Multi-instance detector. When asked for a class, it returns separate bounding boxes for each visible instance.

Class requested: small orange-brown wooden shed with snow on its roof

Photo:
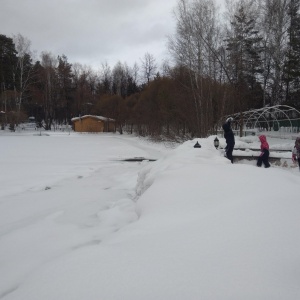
[71,115,115,132]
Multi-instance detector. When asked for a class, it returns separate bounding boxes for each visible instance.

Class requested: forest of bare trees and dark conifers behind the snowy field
[0,0,300,139]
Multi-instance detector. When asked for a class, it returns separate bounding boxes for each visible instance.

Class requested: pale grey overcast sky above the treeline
[0,0,223,69]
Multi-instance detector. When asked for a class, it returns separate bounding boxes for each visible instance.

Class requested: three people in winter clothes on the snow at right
[222,117,300,169]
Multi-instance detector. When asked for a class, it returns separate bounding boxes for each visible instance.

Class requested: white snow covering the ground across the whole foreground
[0,131,300,300]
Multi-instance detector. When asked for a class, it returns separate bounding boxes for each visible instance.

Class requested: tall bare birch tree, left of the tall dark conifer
[169,0,222,136]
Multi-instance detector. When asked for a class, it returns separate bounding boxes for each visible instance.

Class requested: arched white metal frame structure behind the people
[222,105,300,132]
